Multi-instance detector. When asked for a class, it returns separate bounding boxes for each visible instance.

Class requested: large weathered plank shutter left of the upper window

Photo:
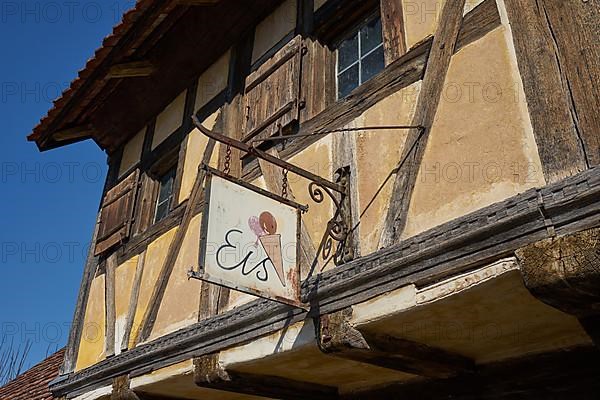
[242,36,302,141]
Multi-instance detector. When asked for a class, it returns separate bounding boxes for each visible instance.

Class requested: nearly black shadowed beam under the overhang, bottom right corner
[342,346,600,400]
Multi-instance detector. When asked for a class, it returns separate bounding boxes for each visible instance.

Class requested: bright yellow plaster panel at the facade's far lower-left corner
[75,275,106,371]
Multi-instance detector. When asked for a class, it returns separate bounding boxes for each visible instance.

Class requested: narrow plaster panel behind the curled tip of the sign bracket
[179,110,221,203]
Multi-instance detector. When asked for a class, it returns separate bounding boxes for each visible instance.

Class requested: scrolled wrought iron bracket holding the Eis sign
[192,115,353,273]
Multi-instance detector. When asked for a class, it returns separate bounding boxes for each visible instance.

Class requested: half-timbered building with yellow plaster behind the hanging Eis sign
[29,0,600,400]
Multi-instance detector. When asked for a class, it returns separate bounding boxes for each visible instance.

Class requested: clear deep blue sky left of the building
[0,0,133,366]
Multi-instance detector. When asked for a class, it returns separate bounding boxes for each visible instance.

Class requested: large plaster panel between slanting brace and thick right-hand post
[404,28,545,237]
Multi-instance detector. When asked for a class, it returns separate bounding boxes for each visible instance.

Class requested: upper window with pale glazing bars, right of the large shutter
[336,16,385,99]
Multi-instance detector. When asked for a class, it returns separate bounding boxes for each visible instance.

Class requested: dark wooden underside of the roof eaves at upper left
[28,0,282,153]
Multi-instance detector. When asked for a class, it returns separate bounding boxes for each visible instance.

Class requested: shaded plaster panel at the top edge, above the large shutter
[252,0,297,62]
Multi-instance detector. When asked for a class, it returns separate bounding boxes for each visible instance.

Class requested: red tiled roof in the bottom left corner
[0,349,65,400]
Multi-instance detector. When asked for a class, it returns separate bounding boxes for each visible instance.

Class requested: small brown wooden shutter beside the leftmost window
[94,170,139,255]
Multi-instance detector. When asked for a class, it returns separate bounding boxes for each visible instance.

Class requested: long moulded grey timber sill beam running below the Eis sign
[51,167,600,395]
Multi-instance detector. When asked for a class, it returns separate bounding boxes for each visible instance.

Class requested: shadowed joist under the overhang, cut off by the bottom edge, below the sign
[194,353,338,400]
